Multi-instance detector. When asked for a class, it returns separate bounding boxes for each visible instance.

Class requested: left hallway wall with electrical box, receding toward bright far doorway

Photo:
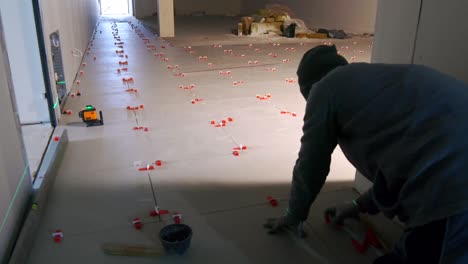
[40,0,99,116]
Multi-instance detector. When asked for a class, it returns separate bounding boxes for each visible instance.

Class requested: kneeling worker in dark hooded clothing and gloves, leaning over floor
[265,46,468,264]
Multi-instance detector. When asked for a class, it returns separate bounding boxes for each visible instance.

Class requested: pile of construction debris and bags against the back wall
[238,4,349,39]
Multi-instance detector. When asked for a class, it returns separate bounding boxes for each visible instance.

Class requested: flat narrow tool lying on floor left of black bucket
[101,243,166,257]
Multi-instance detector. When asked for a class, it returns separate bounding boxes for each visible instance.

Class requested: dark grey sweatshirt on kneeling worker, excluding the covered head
[289,63,468,227]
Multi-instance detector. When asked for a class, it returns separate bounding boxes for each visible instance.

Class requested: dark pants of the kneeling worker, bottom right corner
[374,211,468,264]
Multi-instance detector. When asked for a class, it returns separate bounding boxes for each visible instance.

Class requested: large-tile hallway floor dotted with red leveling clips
[29,19,398,264]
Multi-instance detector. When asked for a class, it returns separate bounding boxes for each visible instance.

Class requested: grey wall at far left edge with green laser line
[0,14,31,263]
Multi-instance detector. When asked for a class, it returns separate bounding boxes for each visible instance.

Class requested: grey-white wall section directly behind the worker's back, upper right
[372,0,468,82]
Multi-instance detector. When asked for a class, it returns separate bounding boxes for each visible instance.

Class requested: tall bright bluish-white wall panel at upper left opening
[0,0,50,123]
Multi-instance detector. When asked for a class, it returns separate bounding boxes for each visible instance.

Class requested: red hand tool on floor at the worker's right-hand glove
[325,211,385,256]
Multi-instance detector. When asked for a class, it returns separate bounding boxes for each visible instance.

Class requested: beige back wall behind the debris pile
[242,0,377,33]
